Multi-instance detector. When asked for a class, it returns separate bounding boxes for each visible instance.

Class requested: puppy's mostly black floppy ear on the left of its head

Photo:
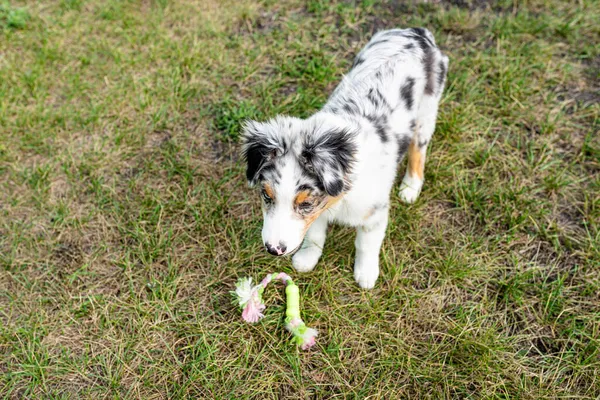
[242,121,283,186]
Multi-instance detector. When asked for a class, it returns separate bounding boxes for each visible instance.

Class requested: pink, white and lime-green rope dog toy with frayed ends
[231,272,318,350]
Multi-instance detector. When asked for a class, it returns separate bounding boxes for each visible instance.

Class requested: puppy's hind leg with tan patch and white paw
[399,56,448,203]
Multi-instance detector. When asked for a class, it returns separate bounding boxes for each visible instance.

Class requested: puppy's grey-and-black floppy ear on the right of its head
[302,129,356,196]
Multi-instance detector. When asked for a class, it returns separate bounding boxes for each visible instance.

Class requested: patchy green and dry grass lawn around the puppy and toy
[0,0,600,399]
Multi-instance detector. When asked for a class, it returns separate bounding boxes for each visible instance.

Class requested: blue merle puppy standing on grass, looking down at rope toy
[243,28,448,288]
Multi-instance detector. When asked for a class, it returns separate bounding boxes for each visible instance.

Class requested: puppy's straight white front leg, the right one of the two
[354,205,388,289]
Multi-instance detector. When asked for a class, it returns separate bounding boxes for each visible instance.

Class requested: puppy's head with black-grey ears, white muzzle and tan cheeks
[243,117,356,255]
